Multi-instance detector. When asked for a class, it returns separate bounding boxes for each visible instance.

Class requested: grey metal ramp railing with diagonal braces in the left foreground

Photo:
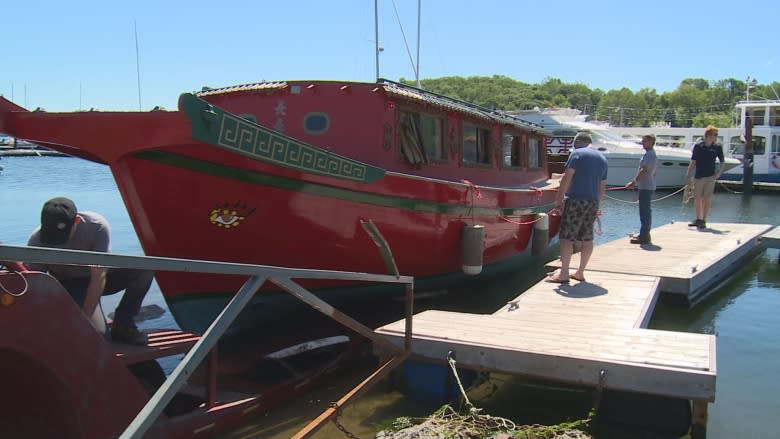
[0,242,414,439]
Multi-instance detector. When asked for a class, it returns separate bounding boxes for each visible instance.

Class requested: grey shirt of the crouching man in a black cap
[27,212,111,279]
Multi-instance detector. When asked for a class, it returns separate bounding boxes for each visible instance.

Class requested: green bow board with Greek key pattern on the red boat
[179,93,385,183]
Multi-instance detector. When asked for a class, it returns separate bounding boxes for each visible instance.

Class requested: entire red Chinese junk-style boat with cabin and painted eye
[0,80,558,332]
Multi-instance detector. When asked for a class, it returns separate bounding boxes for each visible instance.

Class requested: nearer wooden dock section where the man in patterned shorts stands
[376,272,716,401]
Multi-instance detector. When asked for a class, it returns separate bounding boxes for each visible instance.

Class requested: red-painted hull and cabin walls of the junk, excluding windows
[0,83,558,332]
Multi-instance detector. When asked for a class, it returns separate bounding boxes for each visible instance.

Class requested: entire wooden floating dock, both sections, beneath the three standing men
[376,224,772,438]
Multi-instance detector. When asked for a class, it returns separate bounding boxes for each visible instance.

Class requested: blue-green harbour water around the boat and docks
[0,157,780,438]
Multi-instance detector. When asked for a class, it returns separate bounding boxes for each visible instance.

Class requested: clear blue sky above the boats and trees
[0,0,780,111]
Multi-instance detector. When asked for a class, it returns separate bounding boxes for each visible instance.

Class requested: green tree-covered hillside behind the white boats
[399,75,780,127]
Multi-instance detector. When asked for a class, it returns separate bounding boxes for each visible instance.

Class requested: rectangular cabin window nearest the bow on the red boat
[398,111,447,166]
